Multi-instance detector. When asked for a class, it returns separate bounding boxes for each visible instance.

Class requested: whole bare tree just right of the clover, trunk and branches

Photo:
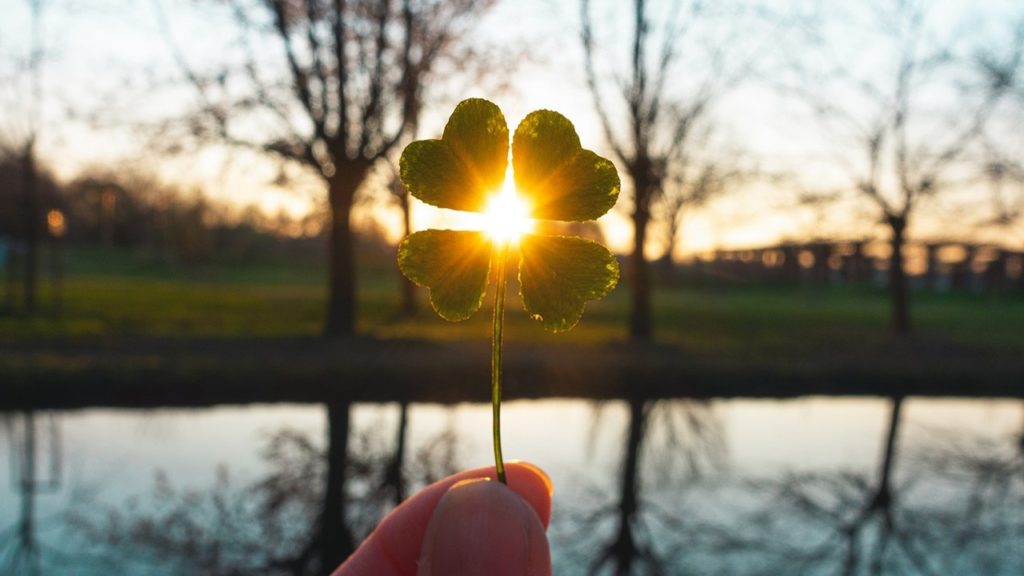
[580,0,750,341]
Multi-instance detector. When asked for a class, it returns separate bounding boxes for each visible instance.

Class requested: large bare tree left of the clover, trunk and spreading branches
[157,0,494,336]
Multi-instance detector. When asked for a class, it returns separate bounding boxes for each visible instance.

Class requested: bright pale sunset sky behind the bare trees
[0,0,1024,256]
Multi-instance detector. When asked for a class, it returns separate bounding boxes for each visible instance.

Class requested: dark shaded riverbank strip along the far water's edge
[0,332,1024,410]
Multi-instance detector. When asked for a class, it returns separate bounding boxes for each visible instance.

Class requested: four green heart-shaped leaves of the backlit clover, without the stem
[398,98,620,331]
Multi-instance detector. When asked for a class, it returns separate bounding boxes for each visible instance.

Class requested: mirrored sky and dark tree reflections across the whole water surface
[0,398,1024,576]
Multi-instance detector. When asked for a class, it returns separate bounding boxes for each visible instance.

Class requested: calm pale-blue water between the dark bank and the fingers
[0,398,1024,575]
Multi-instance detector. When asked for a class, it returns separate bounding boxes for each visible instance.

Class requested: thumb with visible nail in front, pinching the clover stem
[418,479,551,576]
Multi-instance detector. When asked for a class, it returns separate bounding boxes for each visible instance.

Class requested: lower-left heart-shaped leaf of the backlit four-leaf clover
[398,230,492,322]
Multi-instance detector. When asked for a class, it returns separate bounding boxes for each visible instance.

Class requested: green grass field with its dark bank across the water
[0,247,1024,409]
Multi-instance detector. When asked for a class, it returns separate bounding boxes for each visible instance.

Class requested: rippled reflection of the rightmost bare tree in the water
[704,399,1024,575]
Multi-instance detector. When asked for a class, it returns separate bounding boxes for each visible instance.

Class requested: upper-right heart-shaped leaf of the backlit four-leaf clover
[512,110,620,221]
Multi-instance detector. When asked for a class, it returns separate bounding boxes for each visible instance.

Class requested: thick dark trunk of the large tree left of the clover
[324,167,366,337]
